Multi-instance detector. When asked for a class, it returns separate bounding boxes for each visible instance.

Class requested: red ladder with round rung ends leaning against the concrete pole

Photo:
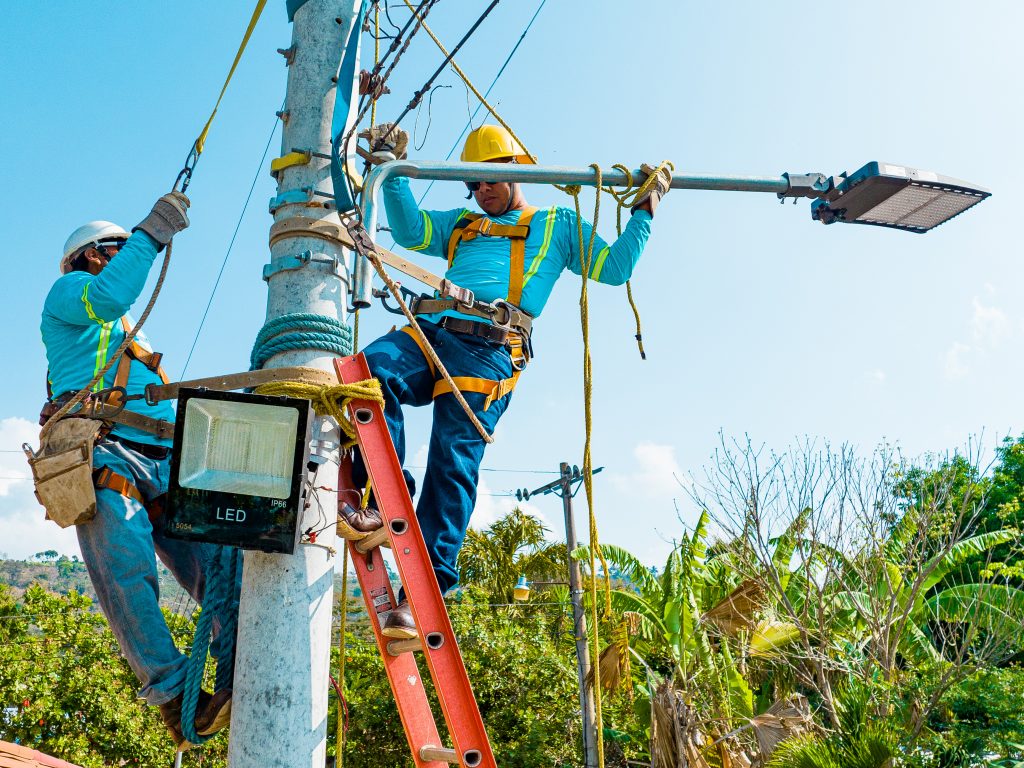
[335,354,496,768]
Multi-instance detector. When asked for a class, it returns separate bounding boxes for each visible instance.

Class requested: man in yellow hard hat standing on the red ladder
[338,123,672,638]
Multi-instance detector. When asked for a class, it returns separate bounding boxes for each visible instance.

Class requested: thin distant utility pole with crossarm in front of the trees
[516,462,604,768]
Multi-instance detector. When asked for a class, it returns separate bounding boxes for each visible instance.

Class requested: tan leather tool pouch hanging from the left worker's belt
[29,418,103,528]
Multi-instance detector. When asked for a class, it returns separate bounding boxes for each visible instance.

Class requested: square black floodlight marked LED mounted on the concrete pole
[165,389,312,553]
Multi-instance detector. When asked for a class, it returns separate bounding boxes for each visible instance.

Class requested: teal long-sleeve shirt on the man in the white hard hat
[40,230,174,445]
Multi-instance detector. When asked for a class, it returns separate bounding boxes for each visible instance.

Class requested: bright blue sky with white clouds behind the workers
[0,0,1024,563]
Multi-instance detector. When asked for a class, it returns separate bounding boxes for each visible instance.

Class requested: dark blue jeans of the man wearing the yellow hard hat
[352,321,513,594]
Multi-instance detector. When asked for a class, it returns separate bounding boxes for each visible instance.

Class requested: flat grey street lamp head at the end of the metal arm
[811,163,991,233]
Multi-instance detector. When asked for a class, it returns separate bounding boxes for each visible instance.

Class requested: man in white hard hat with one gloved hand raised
[40,191,237,749]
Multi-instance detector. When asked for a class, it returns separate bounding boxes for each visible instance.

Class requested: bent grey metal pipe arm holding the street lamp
[352,160,830,307]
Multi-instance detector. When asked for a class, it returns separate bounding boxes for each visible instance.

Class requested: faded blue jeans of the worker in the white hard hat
[77,440,241,705]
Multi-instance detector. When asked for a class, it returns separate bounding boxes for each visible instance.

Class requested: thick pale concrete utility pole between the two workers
[228,0,358,768]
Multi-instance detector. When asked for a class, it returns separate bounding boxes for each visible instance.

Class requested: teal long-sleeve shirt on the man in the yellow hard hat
[384,177,651,323]
